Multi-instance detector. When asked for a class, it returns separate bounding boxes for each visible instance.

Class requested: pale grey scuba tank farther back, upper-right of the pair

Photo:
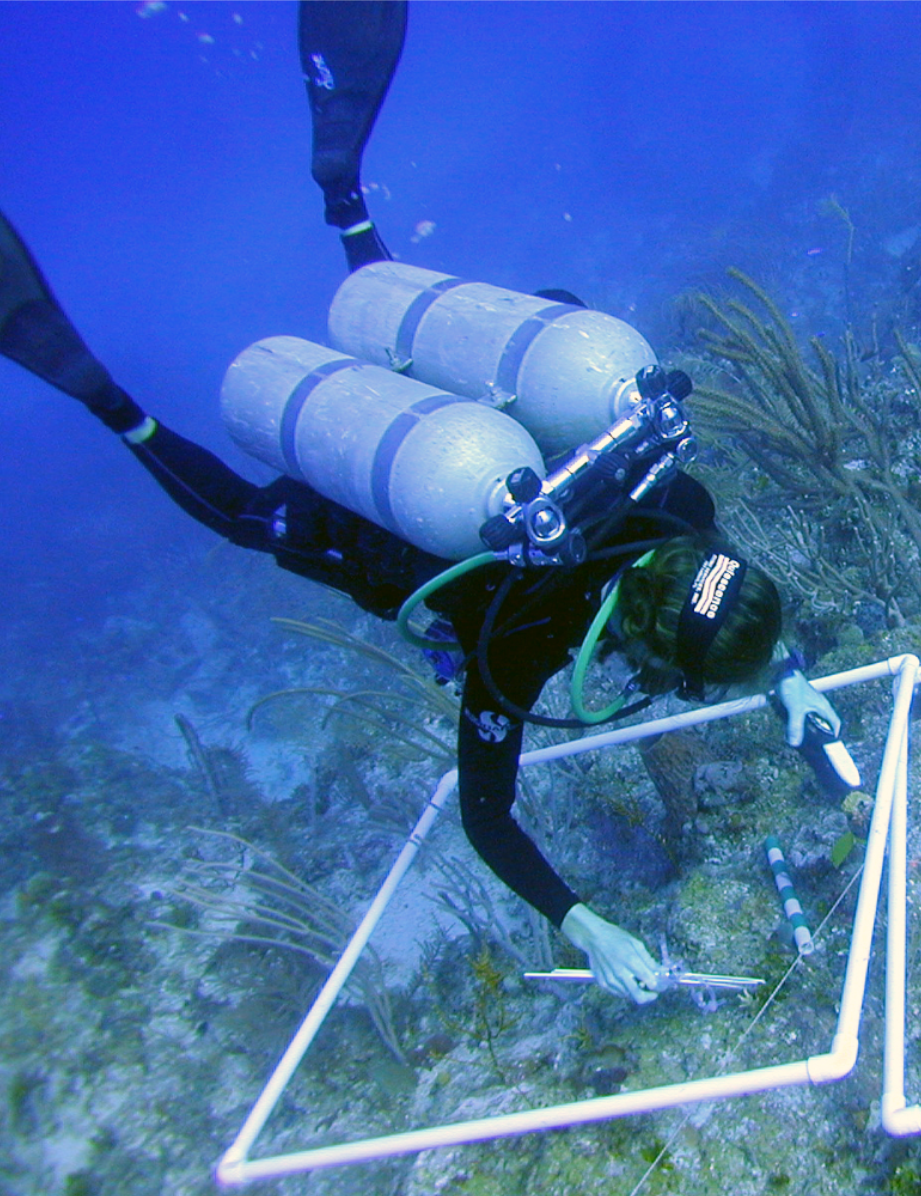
[329,262,655,458]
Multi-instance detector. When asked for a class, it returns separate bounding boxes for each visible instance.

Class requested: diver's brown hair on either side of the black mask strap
[617,536,782,685]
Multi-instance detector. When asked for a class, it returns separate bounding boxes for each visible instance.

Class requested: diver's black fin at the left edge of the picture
[0,212,144,432]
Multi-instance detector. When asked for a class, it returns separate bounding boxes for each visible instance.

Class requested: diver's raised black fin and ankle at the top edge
[299,0,407,270]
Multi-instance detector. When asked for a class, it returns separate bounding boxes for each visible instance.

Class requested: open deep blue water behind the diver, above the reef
[0,0,921,645]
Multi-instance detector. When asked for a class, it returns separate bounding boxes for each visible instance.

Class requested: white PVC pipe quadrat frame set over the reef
[216,654,921,1186]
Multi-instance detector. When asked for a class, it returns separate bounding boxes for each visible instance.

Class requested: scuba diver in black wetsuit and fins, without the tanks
[0,0,840,1003]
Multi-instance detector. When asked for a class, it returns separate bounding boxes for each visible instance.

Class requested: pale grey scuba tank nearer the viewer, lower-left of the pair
[221,336,545,560]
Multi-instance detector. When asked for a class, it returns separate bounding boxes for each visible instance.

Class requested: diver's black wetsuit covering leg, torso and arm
[123,427,714,926]
